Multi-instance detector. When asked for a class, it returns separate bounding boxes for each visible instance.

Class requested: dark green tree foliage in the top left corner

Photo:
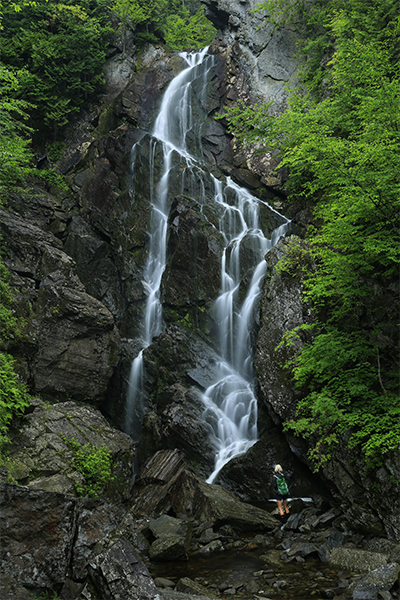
[0,0,108,134]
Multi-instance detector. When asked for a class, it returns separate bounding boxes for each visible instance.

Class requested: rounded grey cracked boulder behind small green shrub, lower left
[5,399,135,500]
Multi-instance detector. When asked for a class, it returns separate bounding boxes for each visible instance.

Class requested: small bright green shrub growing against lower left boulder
[63,438,115,496]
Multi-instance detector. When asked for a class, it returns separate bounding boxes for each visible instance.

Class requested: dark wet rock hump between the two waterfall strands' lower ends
[134,325,218,477]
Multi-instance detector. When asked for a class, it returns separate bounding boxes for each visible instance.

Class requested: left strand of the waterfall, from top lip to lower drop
[124,48,212,441]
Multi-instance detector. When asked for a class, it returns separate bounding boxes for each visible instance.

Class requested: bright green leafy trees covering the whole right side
[227,0,400,468]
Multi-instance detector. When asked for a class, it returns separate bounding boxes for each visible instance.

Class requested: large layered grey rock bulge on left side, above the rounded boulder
[0,211,120,403]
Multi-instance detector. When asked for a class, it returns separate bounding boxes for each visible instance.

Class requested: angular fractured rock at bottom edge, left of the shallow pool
[88,538,159,600]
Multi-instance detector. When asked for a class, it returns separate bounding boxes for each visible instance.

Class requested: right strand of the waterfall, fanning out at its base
[203,178,289,483]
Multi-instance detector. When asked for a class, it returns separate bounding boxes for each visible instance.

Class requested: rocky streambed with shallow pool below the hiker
[145,500,400,600]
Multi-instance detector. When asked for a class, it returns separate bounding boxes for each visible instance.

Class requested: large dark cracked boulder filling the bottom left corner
[0,483,126,589]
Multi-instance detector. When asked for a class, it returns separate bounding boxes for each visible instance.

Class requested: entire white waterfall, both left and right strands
[125,49,289,483]
